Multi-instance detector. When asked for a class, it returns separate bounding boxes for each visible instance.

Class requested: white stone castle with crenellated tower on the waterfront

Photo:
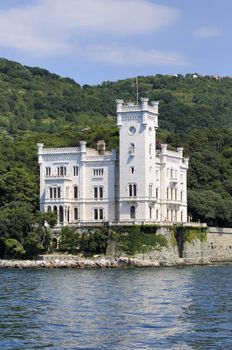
[38,98,188,227]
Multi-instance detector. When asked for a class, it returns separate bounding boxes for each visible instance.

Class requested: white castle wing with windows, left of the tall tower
[38,142,116,224]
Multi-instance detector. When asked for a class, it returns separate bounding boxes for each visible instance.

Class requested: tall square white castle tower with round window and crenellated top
[116,98,159,222]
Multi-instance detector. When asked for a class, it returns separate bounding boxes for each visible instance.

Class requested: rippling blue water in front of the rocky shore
[0,266,232,350]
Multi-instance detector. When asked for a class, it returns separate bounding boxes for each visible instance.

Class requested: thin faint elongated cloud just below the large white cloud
[84,44,188,66]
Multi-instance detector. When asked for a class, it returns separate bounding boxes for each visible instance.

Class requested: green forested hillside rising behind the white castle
[0,59,232,253]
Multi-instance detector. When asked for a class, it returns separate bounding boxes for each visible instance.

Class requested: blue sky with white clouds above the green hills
[0,0,232,85]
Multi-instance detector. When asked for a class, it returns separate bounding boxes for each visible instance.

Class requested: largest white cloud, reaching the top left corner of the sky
[0,0,180,56]
